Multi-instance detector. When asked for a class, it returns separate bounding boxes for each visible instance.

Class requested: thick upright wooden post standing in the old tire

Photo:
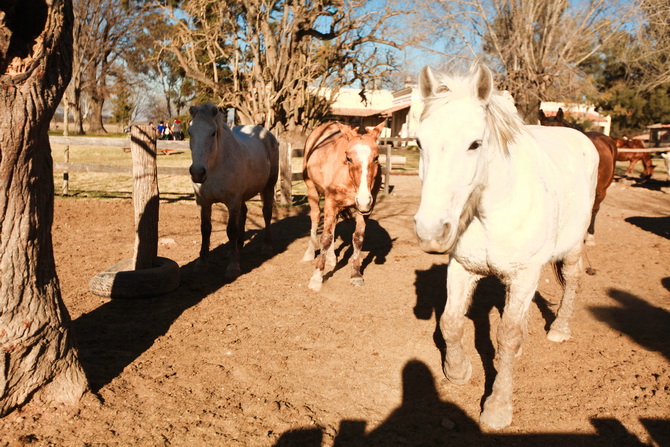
[130,126,159,270]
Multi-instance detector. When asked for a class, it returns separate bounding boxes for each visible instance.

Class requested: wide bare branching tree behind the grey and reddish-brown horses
[163,0,403,131]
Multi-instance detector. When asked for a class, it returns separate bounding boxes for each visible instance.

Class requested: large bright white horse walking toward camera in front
[414,64,598,429]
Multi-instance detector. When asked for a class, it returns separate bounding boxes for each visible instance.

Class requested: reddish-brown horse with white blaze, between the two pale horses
[302,122,385,291]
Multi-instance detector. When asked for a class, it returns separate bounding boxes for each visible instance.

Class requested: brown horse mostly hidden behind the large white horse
[538,109,618,245]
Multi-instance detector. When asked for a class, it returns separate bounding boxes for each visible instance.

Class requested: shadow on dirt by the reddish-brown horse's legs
[323,219,395,281]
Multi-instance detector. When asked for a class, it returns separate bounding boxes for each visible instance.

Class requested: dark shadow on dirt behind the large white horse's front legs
[413,264,505,405]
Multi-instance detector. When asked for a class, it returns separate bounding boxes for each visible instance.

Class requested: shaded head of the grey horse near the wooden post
[188,103,220,183]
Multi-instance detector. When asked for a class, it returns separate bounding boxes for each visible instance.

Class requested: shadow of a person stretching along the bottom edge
[274,360,670,447]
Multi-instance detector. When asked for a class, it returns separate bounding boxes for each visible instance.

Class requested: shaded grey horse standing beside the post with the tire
[188,104,279,278]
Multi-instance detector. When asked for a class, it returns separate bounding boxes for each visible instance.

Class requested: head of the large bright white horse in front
[414,64,510,253]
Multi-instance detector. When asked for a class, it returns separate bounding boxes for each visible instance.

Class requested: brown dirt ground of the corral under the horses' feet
[0,176,670,447]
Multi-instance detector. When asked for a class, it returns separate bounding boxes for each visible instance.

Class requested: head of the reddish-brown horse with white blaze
[338,122,385,214]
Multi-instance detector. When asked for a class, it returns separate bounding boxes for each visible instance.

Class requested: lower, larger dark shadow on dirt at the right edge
[589,288,670,360]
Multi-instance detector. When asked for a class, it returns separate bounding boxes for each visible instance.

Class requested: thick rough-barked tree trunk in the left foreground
[0,0,87,417]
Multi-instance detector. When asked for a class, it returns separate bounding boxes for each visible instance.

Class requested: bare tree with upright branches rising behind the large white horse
[412,0,635,122]
